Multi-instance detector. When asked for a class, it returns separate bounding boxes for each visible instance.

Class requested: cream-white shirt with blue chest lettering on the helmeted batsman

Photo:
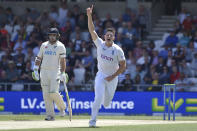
[38,41,66,70]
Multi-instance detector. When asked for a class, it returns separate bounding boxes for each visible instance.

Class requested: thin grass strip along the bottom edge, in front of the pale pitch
[1,124,197,131]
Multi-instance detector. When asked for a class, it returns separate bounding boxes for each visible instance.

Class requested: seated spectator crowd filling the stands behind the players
[0,3,197,91]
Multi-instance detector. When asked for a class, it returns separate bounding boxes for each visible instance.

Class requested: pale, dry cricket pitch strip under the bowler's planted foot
[0,119,197,130]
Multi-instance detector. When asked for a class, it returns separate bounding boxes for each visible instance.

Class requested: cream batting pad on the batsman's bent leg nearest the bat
[50,93,66,110]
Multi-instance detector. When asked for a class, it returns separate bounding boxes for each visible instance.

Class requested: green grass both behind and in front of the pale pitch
[0,115,197,131]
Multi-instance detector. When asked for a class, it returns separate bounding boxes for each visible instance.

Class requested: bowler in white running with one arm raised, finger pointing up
[87,5,126,127]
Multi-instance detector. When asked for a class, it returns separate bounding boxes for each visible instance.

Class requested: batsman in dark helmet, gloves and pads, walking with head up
[32,28,68,121]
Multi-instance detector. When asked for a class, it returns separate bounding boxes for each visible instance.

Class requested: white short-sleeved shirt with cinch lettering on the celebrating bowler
[94,37,125,75]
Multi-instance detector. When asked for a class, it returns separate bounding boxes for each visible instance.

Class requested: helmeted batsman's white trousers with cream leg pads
[40,69,66,117]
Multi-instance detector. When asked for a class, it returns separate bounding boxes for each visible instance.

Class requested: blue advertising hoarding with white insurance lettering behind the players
[0,92,197,115]
